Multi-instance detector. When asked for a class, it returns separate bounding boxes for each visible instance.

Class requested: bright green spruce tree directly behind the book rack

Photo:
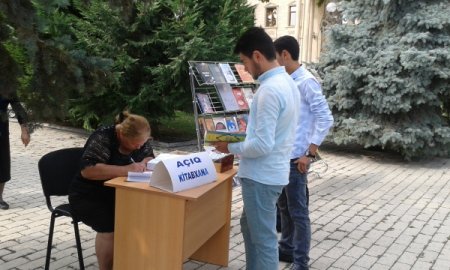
[71,0,253,130]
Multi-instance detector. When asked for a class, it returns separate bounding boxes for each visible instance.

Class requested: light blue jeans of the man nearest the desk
[240,178,283,270]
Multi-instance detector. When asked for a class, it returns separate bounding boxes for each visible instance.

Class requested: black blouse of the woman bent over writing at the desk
[70,126,154,195]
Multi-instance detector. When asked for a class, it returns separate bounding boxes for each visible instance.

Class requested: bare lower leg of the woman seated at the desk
[95,232,114,270]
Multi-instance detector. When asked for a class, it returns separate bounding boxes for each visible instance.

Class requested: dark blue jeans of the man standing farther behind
[278,160,311,270]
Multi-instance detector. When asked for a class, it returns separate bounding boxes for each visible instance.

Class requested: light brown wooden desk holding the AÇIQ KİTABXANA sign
[105,168,236,270]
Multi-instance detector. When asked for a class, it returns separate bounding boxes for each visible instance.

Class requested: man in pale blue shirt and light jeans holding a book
[215,27,300,270]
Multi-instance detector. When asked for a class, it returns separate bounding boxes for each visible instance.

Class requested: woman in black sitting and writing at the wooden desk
[69,111,154,270]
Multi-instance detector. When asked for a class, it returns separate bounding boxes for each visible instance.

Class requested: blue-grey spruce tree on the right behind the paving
[320,0,450,159]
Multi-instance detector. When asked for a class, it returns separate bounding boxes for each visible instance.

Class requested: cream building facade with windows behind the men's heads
[248,0,325,63]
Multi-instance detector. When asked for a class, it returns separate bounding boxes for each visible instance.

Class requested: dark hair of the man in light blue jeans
[234,27,276,61]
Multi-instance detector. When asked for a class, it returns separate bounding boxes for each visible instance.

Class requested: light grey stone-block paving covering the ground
[0,122,450,270]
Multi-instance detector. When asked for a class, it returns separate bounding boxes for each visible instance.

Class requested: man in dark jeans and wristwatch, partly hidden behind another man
[274,36,333,270]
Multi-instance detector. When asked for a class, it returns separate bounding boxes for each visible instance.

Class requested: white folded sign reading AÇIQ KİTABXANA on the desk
[150,152,217,192]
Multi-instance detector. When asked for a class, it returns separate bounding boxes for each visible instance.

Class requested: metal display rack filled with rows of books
[188,61,258,151]
